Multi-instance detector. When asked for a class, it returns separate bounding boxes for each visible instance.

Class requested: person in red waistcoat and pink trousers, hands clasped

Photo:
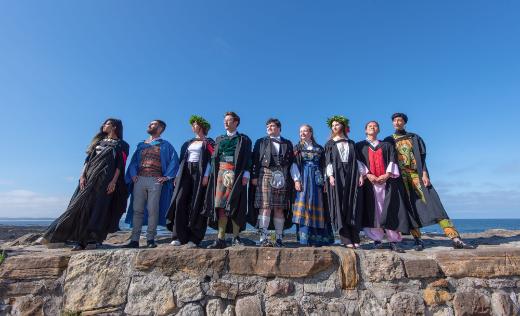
[356,121,410,252]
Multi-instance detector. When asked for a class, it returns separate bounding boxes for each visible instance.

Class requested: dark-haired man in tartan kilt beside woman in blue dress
[249,118,294,247]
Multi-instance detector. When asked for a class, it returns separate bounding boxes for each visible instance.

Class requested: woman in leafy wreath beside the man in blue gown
[166,115,215,247]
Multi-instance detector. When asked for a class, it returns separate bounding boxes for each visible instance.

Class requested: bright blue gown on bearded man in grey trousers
[125,139,179,226]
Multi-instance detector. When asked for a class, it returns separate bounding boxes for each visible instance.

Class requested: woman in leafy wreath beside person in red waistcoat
[325,115,363,248]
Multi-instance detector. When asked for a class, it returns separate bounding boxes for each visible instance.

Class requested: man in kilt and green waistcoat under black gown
[204,112,251,249]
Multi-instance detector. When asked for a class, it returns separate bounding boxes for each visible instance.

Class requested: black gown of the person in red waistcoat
[356,140,410,234]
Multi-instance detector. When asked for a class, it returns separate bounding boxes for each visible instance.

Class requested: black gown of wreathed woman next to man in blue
[166,138,215,244]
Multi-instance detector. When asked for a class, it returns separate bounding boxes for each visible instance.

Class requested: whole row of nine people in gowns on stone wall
[43,112,474,252]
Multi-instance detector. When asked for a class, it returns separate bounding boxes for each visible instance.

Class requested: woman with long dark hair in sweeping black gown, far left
[43,118,129,250]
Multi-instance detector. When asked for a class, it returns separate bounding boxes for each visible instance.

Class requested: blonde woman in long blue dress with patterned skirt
[291,124,334,246]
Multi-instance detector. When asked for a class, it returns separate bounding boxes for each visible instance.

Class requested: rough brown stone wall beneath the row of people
[0,246,520,315]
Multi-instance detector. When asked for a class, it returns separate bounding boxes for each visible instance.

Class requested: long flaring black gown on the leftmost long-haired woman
[43,141,129,245]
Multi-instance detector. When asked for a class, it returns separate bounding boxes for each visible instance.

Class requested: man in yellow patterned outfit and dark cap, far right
[385,113,475,251]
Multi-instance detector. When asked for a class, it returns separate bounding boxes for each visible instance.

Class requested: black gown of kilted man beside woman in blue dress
[247,136,294,230]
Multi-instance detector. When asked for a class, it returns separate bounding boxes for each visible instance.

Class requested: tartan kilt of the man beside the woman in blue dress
[255,168,289,209]
